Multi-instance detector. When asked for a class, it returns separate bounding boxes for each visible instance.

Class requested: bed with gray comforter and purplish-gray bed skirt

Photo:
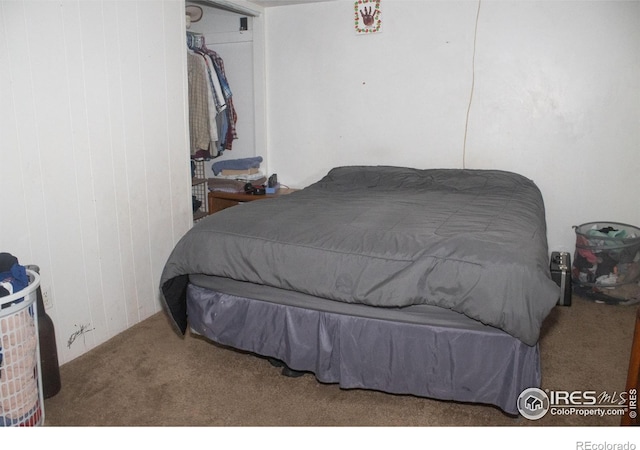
[160,166,560,415]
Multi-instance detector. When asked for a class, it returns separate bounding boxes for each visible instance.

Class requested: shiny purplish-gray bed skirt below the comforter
[187,284,540,415]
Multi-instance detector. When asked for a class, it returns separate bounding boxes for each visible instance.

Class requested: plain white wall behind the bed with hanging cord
[265,0,640,252]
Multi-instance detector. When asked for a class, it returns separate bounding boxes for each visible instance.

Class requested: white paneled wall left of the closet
[0,0,192,363]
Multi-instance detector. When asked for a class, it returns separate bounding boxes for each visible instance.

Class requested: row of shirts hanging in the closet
[187,33,238,159]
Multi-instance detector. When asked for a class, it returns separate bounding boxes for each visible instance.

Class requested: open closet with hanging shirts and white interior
[185,0,268,222]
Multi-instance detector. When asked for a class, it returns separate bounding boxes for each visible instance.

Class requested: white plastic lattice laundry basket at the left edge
[0,269,44,427]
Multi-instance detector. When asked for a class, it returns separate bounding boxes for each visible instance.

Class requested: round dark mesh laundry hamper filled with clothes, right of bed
[571,222,640,304]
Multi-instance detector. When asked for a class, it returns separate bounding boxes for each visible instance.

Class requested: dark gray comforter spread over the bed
[160,166,559,345]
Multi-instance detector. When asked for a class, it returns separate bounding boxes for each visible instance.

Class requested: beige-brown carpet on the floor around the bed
[45,297,637,427]
